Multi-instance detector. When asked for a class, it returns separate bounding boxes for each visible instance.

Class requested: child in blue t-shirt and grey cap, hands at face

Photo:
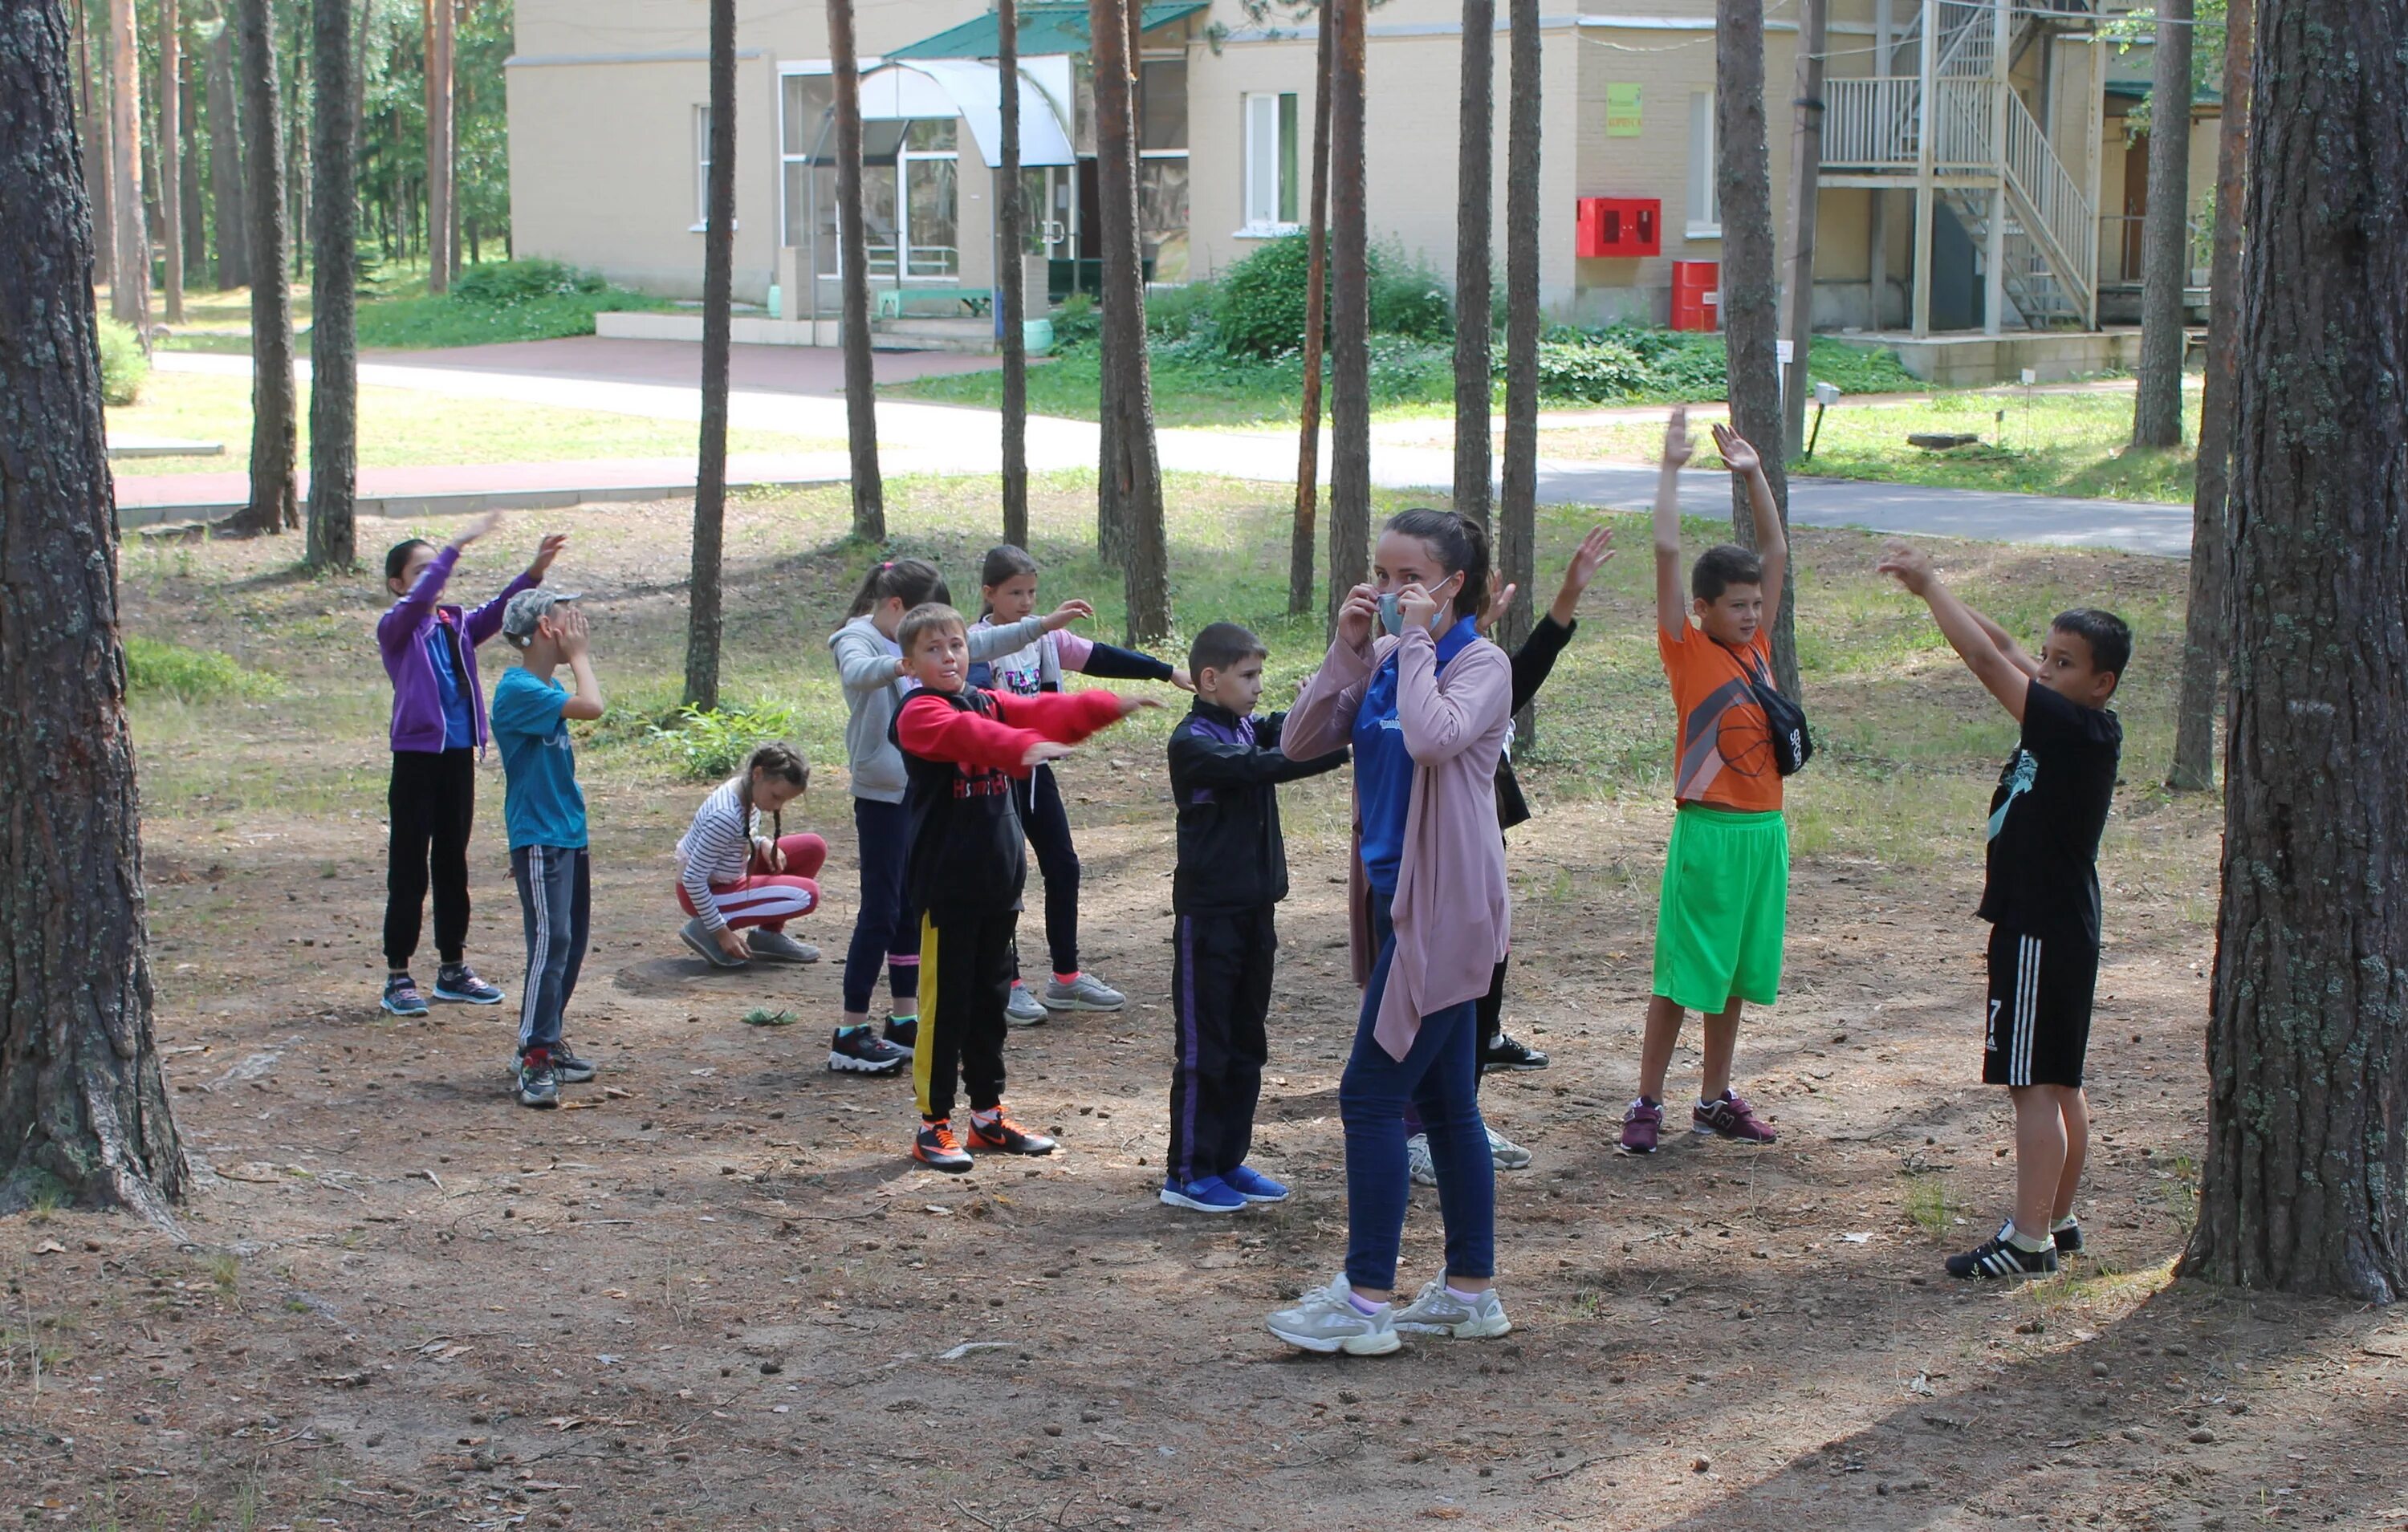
[494,590,602,1106]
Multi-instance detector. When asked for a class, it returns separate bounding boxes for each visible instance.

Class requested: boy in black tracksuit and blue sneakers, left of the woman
[1163,621,1346,1212]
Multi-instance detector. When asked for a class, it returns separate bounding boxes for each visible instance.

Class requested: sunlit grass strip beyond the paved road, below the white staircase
[1539,380,2199,503]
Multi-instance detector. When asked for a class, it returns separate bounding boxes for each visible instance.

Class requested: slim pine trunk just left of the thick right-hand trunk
[2165,0,2256,793]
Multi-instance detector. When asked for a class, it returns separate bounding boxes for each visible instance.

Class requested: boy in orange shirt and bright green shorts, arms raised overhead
[1621,409,1789,1154]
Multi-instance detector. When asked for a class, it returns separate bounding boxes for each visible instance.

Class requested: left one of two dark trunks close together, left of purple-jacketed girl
[224,0,301,534]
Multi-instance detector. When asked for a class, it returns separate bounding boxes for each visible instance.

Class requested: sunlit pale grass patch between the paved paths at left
[108,371,845,477]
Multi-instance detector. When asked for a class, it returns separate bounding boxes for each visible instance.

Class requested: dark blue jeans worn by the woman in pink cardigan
[1339,892,1495,1289]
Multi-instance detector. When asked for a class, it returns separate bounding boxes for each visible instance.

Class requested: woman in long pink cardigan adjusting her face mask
[1271,510,1512,1356]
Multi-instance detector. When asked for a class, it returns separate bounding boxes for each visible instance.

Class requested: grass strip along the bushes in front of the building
[881,337,1914,429]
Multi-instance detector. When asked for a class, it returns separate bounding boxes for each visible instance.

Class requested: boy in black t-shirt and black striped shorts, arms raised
[1878,542,2131,1277]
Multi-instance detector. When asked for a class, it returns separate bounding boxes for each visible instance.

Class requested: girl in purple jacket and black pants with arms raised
[376,510,568,1017]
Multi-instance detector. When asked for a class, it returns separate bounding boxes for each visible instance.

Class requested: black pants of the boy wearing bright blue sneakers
[1170,906,1279,1180]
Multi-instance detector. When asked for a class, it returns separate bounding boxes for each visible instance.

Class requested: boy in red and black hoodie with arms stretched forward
[891,602,1158,1176]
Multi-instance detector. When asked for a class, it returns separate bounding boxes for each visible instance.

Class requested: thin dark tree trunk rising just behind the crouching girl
[684,0,737,713]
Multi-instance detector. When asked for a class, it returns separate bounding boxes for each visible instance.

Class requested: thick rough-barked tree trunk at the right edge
[2160,0,2408,1303]
